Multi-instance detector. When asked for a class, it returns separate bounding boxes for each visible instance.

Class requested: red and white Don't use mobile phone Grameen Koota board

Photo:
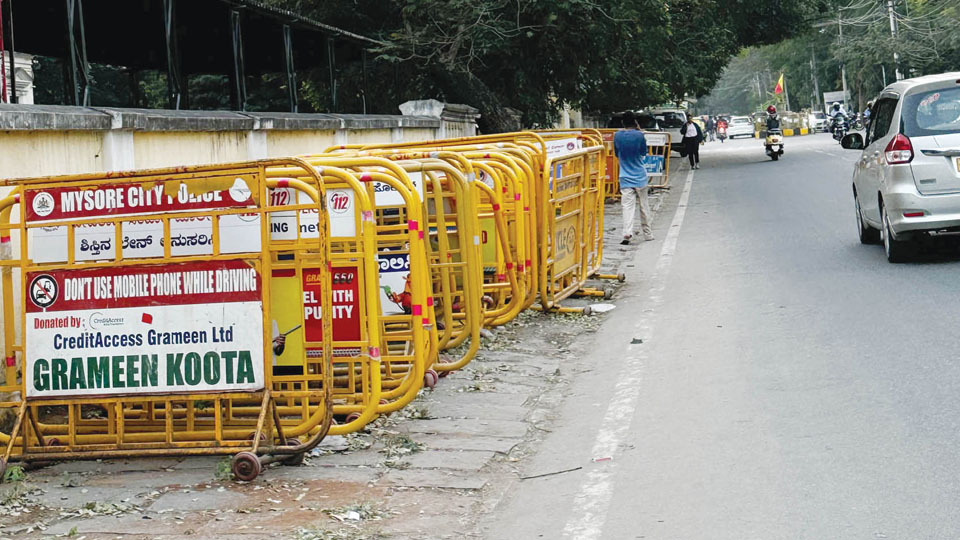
[24,260,264,398]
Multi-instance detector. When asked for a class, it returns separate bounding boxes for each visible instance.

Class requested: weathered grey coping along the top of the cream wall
[0,103,441,131]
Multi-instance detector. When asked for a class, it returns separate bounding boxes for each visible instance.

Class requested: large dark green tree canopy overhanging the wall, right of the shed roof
[272,0,829,131]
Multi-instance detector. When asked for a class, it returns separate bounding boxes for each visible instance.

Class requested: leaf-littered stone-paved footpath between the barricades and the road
[0,164,686,540]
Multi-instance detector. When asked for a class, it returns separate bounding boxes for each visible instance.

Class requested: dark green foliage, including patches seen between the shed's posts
[26,0,828,132]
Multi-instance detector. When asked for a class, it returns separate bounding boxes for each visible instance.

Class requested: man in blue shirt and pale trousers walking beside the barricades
[613,111,653,246]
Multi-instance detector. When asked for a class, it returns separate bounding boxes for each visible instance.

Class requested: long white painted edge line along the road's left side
[563,170,693,540]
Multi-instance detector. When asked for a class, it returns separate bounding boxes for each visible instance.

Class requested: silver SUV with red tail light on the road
[841,72,960,262]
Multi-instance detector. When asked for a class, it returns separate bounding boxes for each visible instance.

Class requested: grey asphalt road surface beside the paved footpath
[484,135,960,540]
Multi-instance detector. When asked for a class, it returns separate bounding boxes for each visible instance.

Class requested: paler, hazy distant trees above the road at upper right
[698,0,960,114]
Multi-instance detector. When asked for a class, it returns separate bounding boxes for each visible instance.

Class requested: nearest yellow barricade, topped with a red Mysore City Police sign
[0,159,344,479]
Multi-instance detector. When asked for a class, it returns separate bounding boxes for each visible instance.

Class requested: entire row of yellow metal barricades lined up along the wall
[0,130,622,480]
